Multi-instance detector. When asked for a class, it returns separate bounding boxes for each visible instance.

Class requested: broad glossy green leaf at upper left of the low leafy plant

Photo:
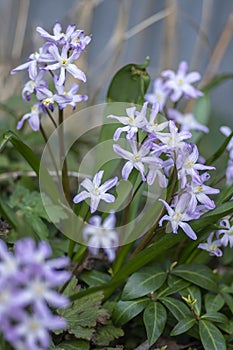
[122,266,167,300]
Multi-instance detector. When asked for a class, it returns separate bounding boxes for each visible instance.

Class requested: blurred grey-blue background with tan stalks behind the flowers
[0,0,233,139]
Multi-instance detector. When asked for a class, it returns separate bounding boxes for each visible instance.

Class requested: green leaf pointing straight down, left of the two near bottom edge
[143,301,167,346]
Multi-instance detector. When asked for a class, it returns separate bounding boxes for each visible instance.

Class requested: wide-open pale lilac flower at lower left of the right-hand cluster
[113,140,162,181]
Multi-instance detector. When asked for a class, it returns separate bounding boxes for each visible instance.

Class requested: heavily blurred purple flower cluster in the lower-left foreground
[0,238,70,350]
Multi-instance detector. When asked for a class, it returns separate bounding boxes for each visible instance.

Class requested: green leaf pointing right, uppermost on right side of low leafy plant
[172,264,218,292]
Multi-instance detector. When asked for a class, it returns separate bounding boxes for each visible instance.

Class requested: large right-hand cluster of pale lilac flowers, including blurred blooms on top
[108,62,219,240]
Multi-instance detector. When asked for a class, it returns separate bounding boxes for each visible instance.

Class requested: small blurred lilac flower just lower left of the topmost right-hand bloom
[144,78,169,112]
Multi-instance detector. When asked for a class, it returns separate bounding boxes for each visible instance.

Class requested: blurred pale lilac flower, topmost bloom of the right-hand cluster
[161,61,203,102]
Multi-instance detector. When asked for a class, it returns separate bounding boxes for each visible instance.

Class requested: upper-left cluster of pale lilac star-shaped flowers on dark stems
[11,22,91,131]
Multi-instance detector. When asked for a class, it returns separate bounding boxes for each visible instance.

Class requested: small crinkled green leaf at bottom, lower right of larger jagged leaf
[93,323,124,346]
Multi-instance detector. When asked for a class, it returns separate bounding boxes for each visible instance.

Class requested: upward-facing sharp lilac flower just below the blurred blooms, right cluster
[156,120,192,153]
